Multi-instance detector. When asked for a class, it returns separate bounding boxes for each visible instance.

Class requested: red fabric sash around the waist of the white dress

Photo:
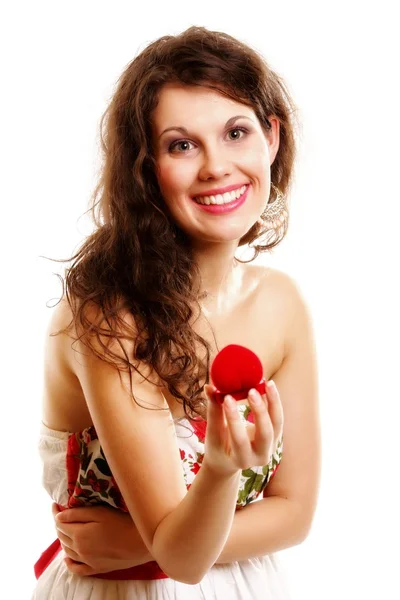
[34,538,168,581]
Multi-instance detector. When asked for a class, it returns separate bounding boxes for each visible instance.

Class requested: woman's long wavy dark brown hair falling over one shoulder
[53,27,296,417]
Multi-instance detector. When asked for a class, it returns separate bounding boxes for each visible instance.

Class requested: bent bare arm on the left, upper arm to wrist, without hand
[74,302,240,584]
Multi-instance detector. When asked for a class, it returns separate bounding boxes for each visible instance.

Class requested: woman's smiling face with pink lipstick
[152,84,279,242]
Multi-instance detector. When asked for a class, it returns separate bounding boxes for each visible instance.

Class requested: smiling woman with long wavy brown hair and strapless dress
[33,27,319,600]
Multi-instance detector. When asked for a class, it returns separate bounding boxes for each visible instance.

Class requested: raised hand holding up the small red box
[203,380,283,475]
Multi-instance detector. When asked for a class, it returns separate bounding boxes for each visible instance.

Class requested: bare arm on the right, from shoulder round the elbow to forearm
[57,275,320,574]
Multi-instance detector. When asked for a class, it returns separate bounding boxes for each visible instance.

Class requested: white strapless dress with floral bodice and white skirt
[32,405,290,600]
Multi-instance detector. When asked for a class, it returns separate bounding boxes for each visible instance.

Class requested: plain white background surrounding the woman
[0,0,400,600]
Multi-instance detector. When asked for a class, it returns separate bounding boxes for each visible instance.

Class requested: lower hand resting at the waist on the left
[52,504,153,576]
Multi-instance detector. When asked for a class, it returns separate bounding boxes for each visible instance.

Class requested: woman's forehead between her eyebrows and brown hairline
[152,84,255,132]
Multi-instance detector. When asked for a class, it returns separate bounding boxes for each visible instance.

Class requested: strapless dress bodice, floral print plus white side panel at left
[39,404,282,512]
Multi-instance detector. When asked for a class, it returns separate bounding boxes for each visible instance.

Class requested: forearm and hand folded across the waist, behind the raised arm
[56,497,307,576]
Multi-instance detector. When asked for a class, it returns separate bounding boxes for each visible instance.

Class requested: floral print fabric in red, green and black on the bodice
[66,404,283,512]
